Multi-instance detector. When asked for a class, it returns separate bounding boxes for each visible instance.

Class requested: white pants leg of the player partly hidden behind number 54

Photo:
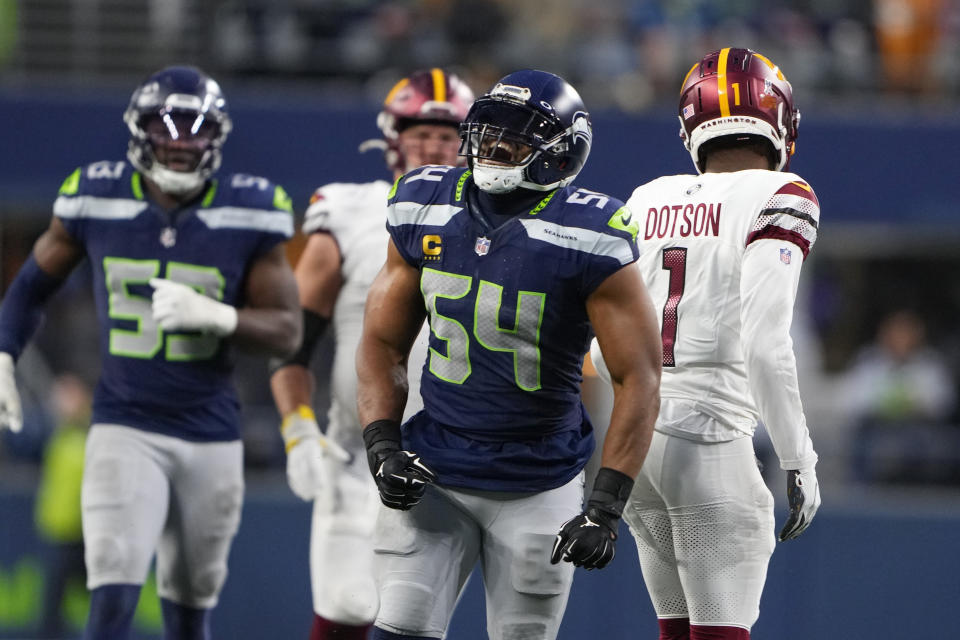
[310,456,380,625]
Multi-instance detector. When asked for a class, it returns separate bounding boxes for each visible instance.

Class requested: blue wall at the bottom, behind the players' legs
[0,485,960,640]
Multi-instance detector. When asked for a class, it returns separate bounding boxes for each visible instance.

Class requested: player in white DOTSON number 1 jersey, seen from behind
[591,48,820,640]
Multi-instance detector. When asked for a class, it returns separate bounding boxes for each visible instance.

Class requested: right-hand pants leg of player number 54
[475,474,583,640]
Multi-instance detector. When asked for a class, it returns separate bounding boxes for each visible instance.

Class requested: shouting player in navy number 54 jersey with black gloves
[357,70,661,640]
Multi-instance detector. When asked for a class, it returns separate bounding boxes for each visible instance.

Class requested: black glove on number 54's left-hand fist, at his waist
[363,420,437,511]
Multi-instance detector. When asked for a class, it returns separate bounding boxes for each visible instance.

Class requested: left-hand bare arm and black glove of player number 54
[357,240,436,510]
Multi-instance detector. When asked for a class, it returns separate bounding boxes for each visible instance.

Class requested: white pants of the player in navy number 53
[81,424,243,609]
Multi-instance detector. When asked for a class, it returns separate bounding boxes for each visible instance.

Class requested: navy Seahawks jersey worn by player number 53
[54,162,293,441]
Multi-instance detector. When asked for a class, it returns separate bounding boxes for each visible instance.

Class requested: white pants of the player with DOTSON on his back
[623,431,775,629]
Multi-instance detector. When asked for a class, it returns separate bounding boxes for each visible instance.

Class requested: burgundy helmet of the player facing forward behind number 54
[370,68,473,171]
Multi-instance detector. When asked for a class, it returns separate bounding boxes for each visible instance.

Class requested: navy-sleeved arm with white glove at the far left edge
[0,218,83,431]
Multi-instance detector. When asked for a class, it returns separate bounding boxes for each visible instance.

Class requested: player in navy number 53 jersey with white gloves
[0,67,302,640]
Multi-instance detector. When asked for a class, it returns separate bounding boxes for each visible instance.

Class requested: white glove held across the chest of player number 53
[150,278,237,336]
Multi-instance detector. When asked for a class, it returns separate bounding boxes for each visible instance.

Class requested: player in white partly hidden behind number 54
[271,69,473,640]
